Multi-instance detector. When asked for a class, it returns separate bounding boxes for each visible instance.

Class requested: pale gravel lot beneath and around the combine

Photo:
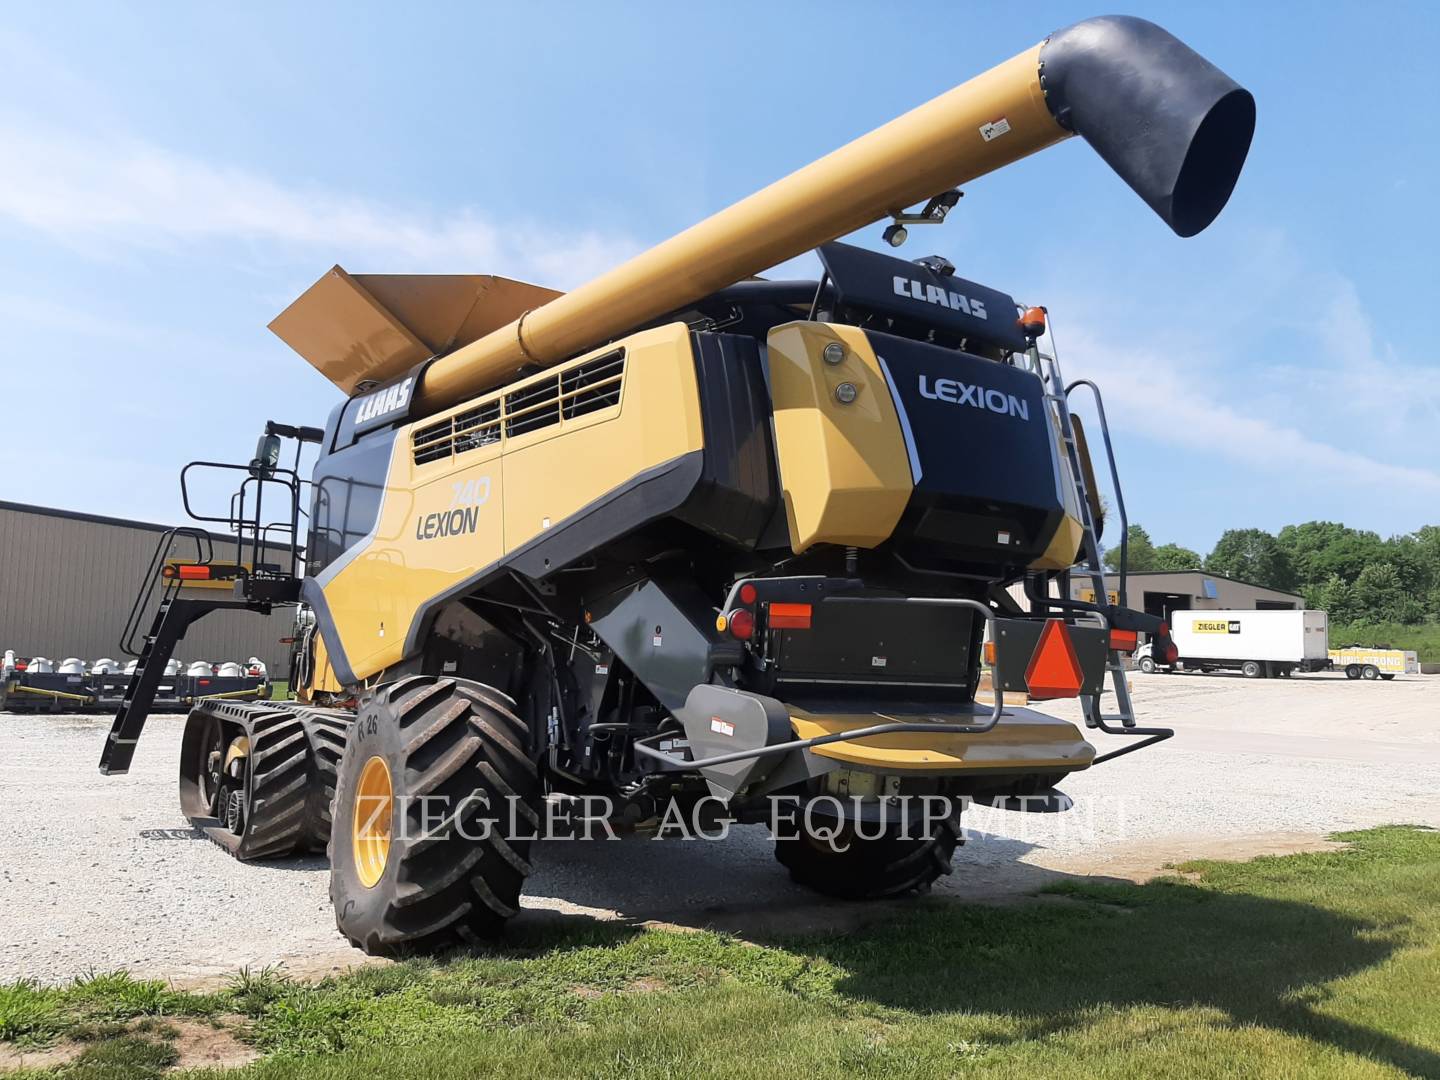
[0,674,1440,985]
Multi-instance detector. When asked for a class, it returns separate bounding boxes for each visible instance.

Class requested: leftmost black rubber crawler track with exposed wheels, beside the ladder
[180,703,310,860]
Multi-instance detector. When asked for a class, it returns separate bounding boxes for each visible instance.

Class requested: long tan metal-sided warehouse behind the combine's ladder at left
[0,501,294,678]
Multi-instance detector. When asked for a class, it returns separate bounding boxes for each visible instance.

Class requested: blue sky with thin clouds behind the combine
[0,1,1440,553]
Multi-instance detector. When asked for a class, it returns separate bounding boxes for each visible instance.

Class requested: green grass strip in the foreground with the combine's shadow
[0,827,1440,1080]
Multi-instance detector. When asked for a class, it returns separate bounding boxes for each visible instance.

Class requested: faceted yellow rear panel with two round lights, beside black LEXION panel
[769,323,913,554]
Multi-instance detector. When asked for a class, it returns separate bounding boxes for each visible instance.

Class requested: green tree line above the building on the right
[1104,521,1440,625]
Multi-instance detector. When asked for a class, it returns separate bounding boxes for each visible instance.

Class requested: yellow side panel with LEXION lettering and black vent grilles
[317,323,704,680]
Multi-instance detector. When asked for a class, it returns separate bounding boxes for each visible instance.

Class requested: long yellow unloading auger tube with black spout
[412,16,1256,415]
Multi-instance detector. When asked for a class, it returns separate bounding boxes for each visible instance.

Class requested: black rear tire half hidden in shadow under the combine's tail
[775,806,960,900]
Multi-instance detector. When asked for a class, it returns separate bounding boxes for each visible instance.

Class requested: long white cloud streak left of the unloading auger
[0,115,638,288]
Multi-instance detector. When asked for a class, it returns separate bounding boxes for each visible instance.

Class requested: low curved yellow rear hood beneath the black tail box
[791,707,1094,773]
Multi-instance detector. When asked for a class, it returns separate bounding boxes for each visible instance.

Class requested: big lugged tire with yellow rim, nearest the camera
[330,675,540,956]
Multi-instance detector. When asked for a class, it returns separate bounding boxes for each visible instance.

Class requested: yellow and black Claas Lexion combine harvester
[101,17,1254,953]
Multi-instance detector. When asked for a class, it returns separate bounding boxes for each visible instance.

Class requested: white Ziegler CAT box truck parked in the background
[1138,611,1331,678]
